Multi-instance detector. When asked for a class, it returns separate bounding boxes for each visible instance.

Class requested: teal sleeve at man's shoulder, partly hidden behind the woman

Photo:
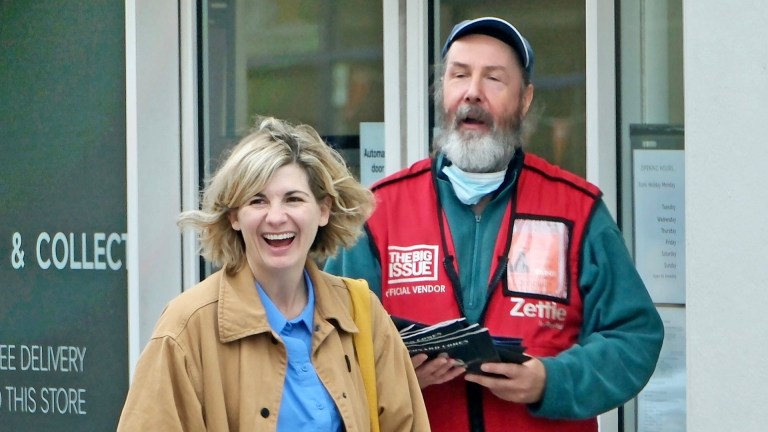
[324,233,381,298]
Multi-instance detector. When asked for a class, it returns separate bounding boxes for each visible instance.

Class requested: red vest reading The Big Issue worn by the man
[368,154,600,432]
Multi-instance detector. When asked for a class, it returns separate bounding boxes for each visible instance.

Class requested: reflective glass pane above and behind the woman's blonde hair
[200,0,384,179]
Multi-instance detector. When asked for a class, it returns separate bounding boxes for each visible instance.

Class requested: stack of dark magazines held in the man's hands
[392,317,530,373]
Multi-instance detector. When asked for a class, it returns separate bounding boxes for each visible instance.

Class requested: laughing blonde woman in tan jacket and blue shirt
[118,118,429,432]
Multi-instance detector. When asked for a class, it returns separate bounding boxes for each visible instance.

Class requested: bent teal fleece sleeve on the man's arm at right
[530,202,664,418]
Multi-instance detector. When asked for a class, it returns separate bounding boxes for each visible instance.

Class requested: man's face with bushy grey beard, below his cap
[436,35,533,172]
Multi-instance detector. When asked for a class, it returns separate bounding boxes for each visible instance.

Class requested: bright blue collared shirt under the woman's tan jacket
[256,270,342,432]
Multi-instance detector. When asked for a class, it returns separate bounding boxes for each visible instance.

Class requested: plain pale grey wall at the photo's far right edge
[683,0,768,432]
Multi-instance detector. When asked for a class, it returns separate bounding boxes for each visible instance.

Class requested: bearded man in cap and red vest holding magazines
[326,18,663,432]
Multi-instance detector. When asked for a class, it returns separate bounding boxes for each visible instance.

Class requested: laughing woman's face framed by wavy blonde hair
[229,164,330,275]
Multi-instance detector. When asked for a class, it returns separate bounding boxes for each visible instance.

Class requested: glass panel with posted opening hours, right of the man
[616,0,686,432]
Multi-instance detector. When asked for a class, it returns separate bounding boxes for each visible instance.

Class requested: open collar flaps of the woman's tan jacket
[218,259,358,343]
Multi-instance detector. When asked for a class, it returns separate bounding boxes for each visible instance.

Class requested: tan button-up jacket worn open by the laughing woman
[118,261,429,432]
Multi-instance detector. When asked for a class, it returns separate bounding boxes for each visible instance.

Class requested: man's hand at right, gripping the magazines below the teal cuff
[462,358,547,404]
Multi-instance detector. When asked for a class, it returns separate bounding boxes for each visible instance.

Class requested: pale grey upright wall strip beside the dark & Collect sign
[125,0,187,370]
